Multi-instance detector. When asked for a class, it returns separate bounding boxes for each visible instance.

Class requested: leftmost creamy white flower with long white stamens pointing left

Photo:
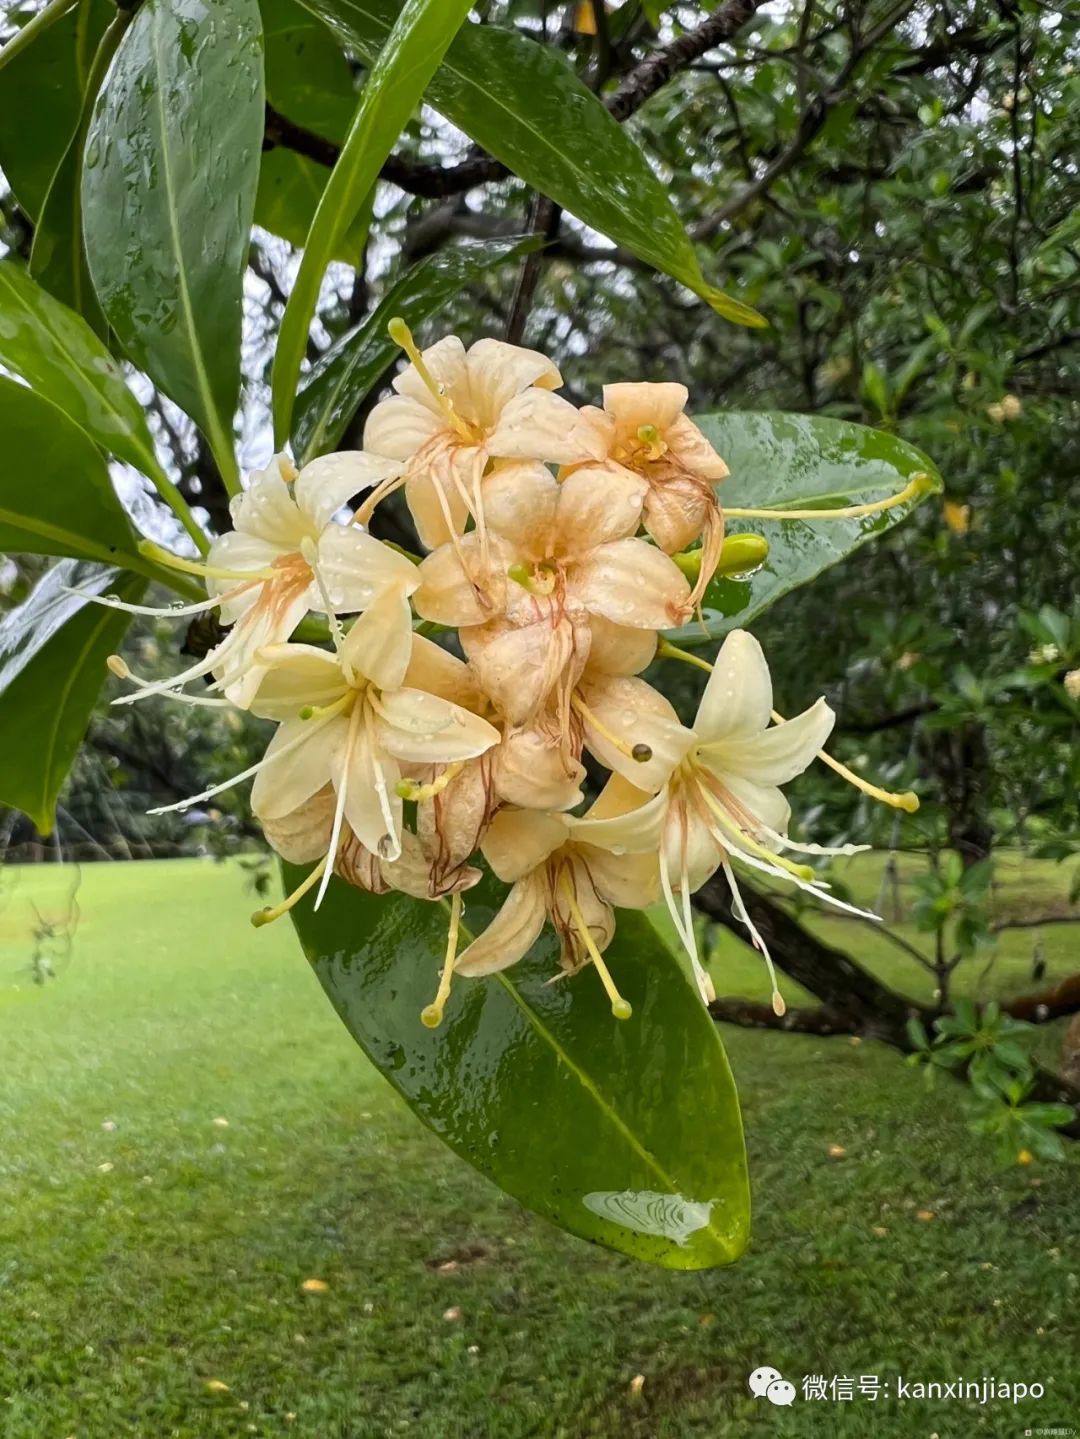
[106,453,418,708]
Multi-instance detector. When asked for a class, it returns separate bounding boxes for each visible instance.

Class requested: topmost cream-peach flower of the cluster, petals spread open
[361,321,582,550]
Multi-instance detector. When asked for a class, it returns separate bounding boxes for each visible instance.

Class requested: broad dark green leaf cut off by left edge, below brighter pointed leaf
[0,377,144,570]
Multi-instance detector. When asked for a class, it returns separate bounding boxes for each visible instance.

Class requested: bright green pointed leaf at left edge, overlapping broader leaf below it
[0,260,160,475]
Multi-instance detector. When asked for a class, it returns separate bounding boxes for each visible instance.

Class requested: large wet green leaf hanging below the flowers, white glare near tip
[286,866,749,1269]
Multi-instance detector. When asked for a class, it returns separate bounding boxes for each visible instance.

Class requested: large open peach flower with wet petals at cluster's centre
[414,463,689,728]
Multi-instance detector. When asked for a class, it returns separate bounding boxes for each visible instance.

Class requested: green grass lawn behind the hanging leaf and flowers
[0,858,1080,1439]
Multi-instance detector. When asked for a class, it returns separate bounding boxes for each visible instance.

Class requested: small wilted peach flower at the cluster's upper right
[578,383,728,604]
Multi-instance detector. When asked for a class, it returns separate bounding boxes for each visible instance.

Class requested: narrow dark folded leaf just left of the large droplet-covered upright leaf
[30,10,131,335]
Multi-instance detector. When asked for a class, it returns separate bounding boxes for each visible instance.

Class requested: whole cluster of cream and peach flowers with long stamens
[105,321,909,1025]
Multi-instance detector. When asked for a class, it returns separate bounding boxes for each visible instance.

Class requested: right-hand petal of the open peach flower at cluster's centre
[567,540,690,630]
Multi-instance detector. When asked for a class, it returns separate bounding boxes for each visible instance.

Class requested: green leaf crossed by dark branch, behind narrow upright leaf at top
[255,0,367,253]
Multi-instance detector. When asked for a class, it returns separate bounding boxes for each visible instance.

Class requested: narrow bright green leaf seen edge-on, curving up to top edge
[272,0,469,446]
